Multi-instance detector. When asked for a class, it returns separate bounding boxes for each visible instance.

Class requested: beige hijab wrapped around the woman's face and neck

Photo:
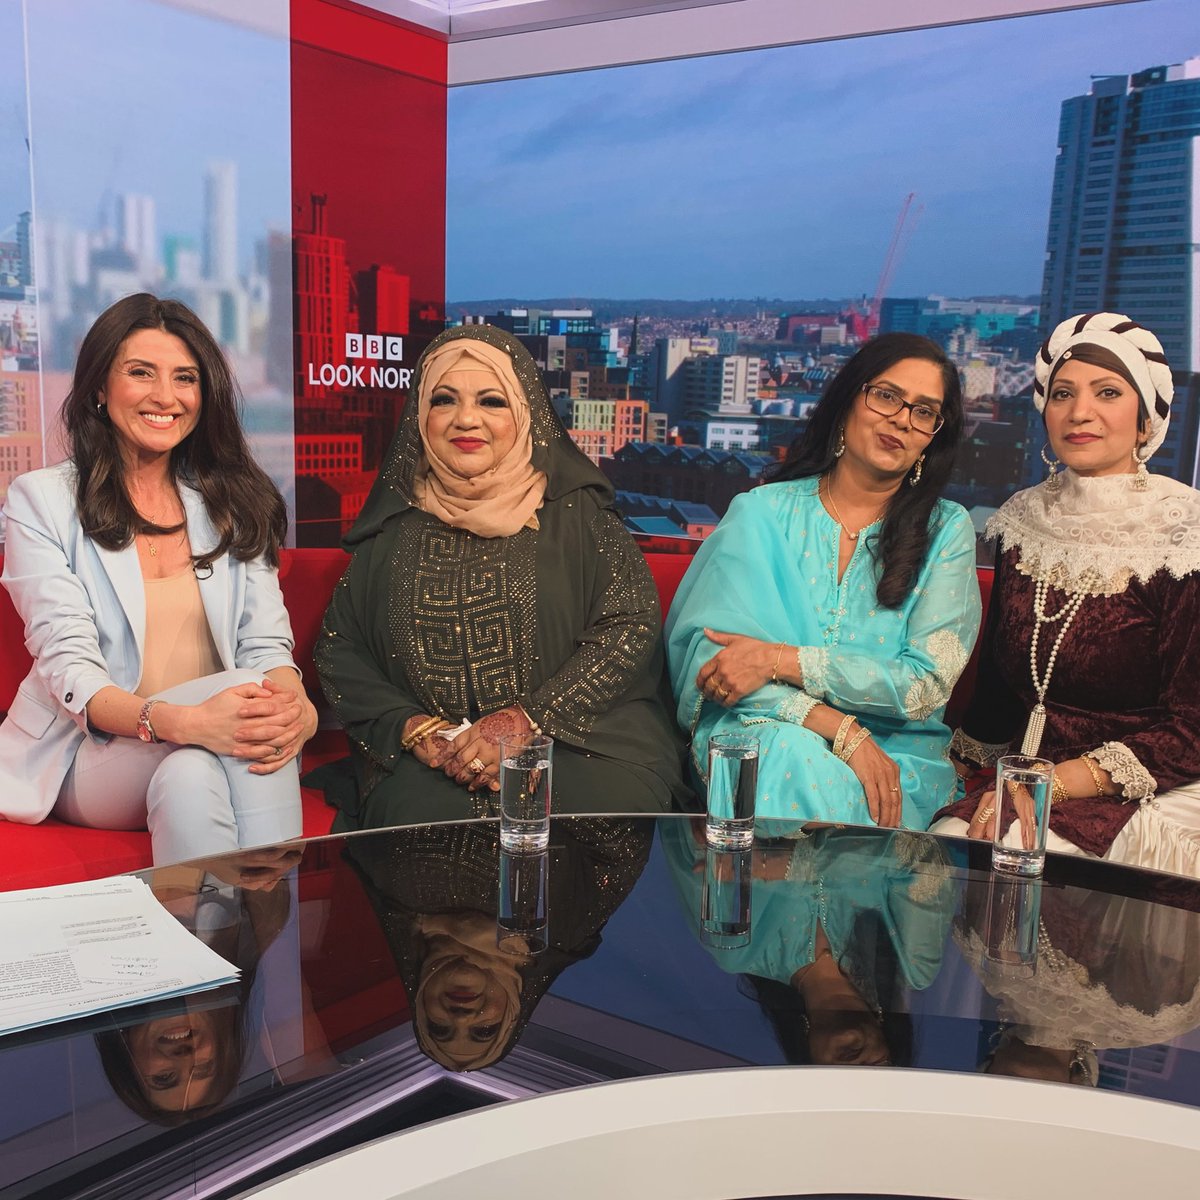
[413,338,546,538]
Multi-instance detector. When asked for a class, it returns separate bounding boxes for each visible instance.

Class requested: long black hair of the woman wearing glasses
[772,334,962,608]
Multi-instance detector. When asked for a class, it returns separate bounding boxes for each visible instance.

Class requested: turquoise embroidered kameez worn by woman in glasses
[666,478,980,829]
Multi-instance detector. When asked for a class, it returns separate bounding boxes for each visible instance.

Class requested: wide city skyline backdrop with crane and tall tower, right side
[446,0,1200,540]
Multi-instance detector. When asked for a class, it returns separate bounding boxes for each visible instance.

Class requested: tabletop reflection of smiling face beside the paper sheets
[125,1012,220,1112]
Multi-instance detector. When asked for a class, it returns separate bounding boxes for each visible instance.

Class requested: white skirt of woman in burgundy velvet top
[929,780,1200,878]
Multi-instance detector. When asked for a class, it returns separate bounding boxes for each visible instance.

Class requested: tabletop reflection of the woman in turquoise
[661,822,958,1066]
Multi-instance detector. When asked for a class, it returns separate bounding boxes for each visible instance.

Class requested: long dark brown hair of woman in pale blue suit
[61,292,288,569]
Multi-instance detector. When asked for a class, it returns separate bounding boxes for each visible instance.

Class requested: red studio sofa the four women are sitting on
[0,550,992,892]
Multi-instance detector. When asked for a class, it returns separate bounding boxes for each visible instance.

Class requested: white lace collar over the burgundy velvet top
[986,468,1200,595]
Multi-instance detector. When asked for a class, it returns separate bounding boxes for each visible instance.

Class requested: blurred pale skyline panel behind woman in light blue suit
[0,0,294,525]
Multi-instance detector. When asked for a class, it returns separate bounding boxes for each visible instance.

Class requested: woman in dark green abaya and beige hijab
[316,325,686,829]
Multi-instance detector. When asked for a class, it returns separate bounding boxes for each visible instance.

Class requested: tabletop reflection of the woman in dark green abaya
[346,818,653,1072]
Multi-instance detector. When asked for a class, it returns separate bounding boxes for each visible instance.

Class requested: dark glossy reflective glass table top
[0,816,1200,1200]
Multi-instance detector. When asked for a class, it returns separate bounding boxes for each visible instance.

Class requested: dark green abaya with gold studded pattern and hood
[316,325,686,829]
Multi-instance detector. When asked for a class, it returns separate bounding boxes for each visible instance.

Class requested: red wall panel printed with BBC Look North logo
[290,0,446,546]
